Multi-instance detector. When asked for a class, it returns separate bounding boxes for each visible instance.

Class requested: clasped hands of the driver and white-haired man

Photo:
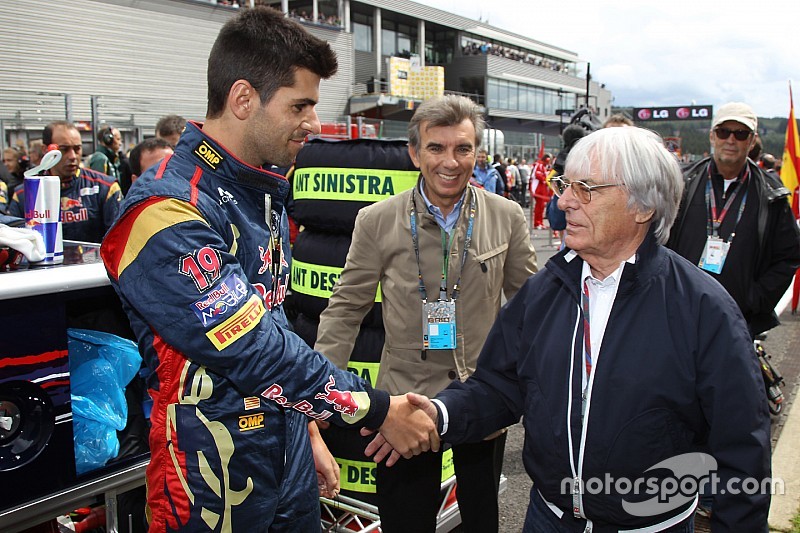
[368,392,439,466]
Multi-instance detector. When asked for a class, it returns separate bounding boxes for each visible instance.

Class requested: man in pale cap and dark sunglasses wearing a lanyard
[667,102,800,335]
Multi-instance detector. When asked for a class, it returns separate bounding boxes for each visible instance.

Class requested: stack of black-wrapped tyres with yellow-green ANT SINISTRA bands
[287,139,419,503]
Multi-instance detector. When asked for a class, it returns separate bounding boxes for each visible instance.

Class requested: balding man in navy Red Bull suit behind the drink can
[8,120,122,242]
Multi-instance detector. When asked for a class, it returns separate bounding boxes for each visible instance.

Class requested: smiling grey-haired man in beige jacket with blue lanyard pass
[315,96,536,533]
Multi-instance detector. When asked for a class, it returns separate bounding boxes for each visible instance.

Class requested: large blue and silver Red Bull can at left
[25,176,64,265]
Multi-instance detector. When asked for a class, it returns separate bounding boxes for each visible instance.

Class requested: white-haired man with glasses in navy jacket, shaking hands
[376,127,770,533]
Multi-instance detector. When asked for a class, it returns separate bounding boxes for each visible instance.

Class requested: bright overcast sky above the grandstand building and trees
[424,0,800,117]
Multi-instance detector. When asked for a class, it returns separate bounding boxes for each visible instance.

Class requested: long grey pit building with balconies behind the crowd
[0,0,611,156]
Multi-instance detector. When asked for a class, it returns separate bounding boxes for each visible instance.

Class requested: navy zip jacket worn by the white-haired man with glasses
[437,233,770,531]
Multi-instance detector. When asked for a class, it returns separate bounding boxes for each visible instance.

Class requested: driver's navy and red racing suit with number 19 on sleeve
[101,123,389,531]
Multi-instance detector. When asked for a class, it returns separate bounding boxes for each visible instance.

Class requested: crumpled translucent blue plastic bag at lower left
[67,329,142,474]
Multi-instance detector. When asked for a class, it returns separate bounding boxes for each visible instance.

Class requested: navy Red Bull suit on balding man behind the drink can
[8,168,122,243]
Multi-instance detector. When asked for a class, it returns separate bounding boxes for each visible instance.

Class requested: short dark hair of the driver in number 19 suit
[206,6,338,118]
